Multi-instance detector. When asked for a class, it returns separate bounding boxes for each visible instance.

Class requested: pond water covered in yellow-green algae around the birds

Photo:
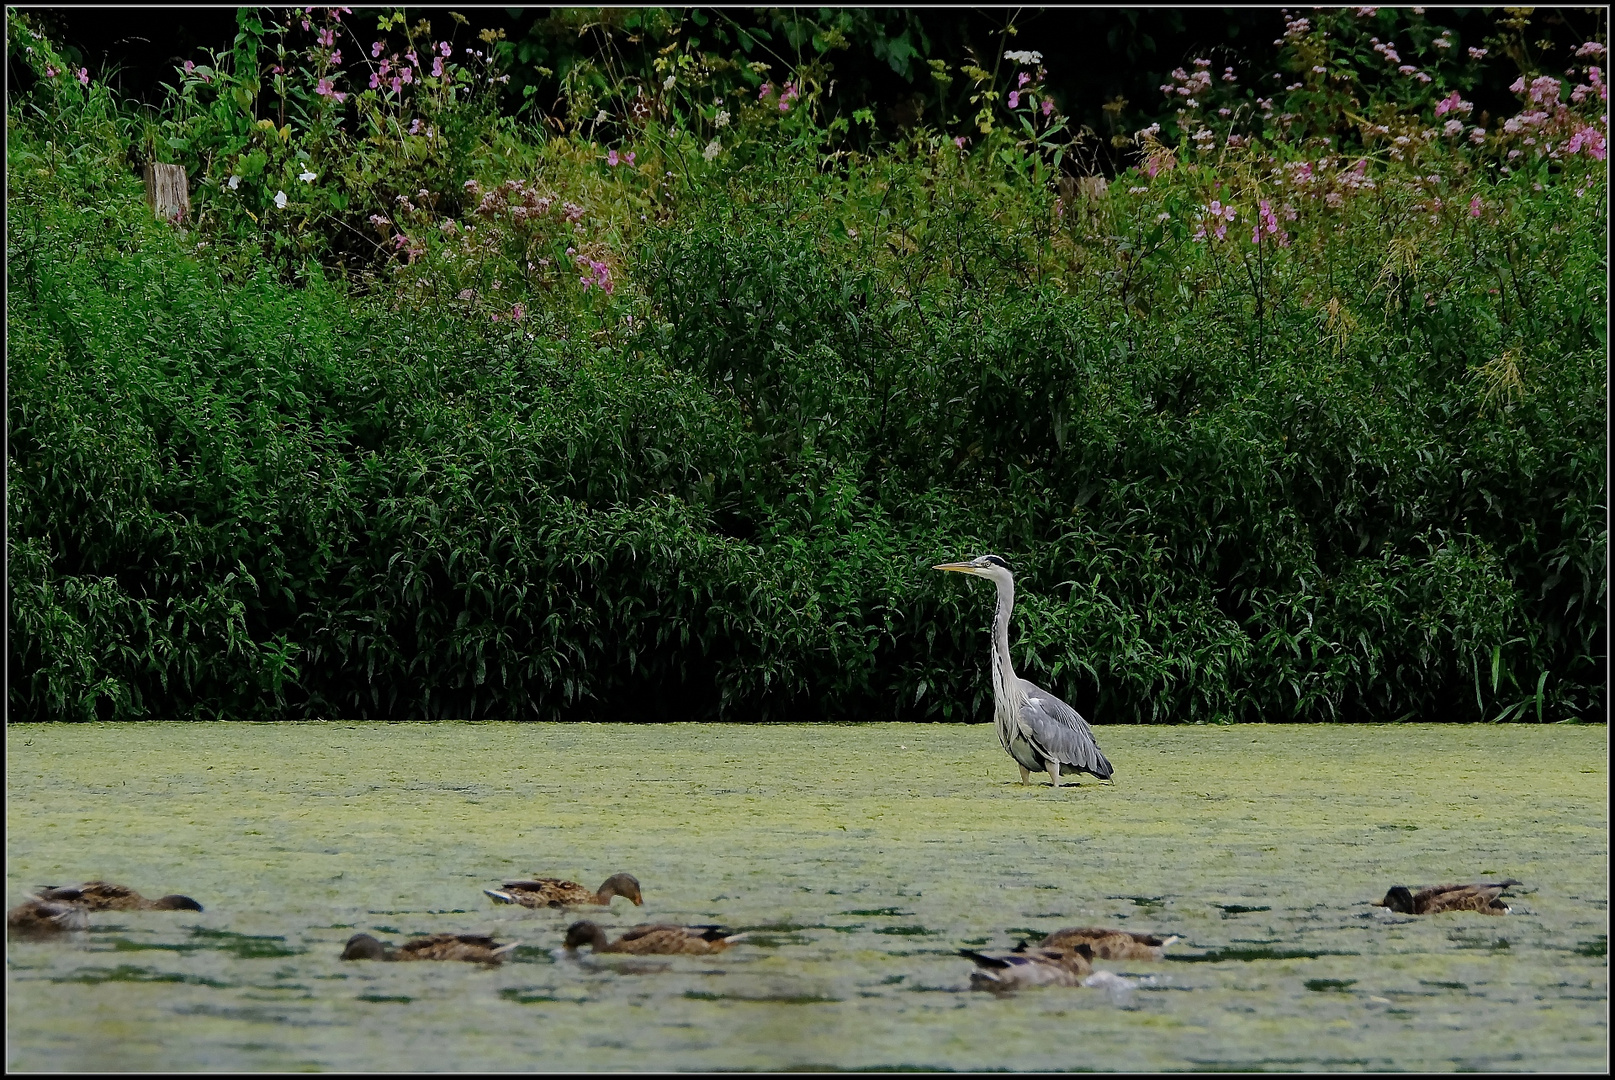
[6,723,1609,1070]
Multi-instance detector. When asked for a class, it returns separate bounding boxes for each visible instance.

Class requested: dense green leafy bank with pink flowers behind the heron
[6,10,1607,722]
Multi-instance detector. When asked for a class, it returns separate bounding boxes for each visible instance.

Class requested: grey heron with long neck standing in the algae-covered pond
[932,555,1111,788]
